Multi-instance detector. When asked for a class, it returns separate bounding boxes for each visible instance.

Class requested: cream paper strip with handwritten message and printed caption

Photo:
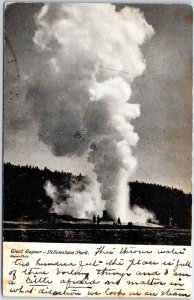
[3,242,192,298]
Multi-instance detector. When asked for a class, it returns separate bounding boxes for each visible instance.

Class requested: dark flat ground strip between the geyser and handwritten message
[3,222,191,245]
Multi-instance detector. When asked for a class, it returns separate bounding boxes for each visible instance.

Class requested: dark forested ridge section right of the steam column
[130,182,192,228]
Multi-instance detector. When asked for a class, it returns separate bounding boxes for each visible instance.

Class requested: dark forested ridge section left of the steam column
[4,163,84,220]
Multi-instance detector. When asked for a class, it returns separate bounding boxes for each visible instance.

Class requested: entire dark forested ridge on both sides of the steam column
[4,163,192,228]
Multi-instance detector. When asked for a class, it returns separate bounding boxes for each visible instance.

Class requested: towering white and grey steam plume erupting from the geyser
[27,3,154,222]
